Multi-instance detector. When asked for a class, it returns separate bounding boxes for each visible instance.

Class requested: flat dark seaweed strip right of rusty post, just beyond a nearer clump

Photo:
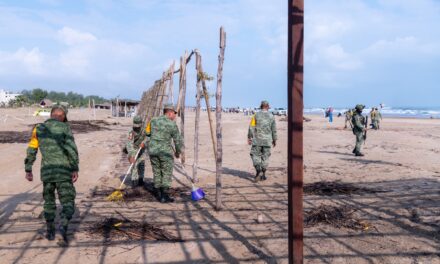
[304,181,381,196]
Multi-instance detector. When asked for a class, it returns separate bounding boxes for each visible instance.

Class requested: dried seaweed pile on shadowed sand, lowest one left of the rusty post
[89,214,183,243]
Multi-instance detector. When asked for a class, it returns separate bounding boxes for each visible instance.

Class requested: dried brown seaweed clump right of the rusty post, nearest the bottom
[304,205,371,231]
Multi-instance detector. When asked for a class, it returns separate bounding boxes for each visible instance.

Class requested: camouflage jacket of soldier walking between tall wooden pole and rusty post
[248,111,277,146]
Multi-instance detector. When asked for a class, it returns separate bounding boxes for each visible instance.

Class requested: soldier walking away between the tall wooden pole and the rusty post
[248,101,277,182]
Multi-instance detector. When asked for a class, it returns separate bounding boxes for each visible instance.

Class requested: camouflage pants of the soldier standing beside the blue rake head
[150,155,174,188]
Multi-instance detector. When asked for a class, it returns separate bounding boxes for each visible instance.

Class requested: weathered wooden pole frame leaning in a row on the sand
[137,27,226,210]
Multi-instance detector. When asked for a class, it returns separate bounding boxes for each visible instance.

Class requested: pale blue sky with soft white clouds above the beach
[0,0,440,107]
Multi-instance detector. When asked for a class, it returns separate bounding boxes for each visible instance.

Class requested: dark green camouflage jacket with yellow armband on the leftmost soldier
[24,119,79,182]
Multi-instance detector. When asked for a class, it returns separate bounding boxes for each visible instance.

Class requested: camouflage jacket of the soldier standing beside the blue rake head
[146,115,183,155]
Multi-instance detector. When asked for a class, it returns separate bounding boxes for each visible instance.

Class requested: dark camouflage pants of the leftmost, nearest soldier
[43,181,76,225]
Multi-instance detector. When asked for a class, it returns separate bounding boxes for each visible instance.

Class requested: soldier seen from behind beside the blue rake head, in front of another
[146,104,182,203]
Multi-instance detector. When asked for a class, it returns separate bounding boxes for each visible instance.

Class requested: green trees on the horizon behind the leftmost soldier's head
[21,88,108,107]
